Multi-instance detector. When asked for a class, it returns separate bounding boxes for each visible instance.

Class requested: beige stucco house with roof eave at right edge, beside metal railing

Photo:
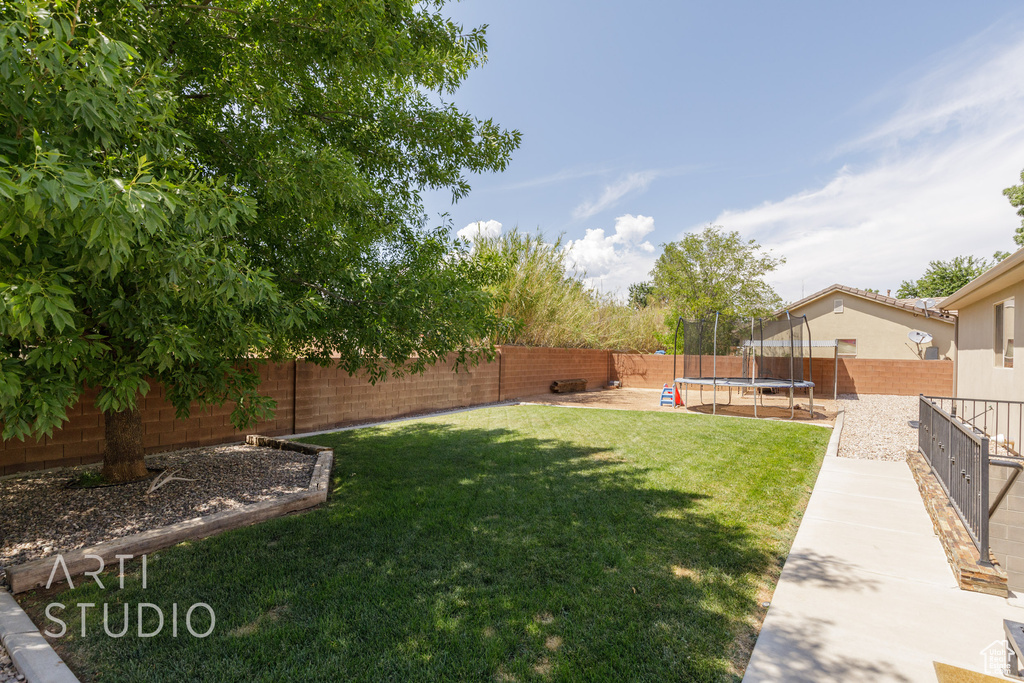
[942,249,1024,400]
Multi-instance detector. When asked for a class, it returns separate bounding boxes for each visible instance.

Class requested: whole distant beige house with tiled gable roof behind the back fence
[781,285,956,360]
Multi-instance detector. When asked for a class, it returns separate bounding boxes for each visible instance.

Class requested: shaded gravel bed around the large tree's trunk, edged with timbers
[0,444,316,577]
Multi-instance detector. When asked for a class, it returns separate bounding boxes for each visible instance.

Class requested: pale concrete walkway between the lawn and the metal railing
[743,457,1024,683]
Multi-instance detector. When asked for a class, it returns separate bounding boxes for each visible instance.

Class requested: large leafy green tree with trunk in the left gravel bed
[0,0,519,480]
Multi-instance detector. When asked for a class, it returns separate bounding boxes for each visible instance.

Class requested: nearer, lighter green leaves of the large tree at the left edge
[0,2,282,438]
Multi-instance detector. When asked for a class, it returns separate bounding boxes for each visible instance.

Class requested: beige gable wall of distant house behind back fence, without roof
[791,292,953,360]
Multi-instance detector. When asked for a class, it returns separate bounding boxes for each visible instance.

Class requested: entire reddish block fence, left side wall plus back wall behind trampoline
[0,346,952,474]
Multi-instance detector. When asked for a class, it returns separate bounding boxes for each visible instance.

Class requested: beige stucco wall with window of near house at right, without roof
[956,281,1024,400]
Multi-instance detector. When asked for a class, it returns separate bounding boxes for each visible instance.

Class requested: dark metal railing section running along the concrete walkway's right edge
[918,396,989,562]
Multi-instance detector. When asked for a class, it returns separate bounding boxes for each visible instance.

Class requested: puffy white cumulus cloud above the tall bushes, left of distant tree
[564,214,656,294]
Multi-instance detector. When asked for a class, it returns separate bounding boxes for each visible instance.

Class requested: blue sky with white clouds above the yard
[426,0,1024,301]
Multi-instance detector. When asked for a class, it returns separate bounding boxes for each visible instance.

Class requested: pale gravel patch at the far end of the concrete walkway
[839,394,918,460]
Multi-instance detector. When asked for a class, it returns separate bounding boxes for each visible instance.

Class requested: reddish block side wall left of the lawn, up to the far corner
[0,347,610,474]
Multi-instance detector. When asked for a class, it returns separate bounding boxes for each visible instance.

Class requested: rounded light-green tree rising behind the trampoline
[651,225,785,327]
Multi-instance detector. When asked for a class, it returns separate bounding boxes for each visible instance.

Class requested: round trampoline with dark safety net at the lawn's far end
[672,311,835,419]
